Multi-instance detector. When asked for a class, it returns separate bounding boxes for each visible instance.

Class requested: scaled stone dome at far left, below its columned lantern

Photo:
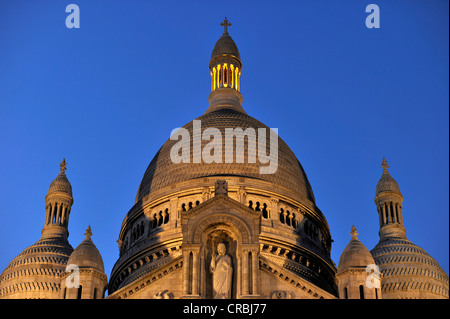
[0,238,73,299]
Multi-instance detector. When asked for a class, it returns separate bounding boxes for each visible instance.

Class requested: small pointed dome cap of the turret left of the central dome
[67,226,105,273]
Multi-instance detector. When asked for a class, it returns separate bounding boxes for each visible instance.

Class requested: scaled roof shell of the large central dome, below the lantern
[136,108,315,207]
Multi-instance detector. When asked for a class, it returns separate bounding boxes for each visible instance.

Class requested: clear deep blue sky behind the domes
[0,0,449,286]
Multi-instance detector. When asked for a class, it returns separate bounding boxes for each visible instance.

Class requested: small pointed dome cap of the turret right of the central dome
[338,226,375,273]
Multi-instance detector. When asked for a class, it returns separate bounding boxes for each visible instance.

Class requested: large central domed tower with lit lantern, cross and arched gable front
[108,19,337,298]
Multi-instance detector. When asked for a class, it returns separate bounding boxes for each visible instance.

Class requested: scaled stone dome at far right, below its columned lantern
[371,237,449,299]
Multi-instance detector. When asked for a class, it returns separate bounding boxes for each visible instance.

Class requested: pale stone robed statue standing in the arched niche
[209,243,233,299]
